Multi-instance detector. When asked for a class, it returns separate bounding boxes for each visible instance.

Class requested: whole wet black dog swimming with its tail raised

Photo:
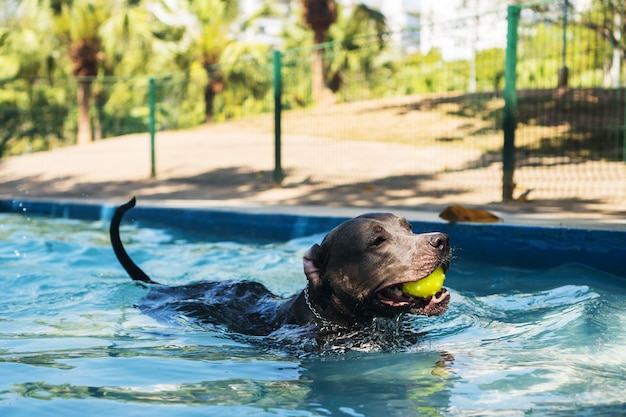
[110,198,450,340]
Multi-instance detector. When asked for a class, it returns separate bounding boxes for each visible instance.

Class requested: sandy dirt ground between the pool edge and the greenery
[0,126,626,225]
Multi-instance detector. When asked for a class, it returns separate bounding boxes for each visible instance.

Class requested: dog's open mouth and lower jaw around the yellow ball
[376,266,450,316]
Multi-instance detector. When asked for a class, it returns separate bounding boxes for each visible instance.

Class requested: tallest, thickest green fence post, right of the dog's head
[502,6,521,201]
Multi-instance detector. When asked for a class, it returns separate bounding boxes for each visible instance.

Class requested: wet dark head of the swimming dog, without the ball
[304,213,450,326]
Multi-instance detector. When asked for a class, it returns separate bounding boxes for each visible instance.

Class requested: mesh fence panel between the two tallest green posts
[276,7,506,201]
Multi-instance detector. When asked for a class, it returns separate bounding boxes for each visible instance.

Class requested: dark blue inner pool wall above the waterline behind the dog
[0,200,626,277]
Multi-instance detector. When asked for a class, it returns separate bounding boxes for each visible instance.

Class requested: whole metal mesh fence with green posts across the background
[0,1,626,206]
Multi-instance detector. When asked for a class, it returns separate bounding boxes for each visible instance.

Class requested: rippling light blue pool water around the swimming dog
[0,214,626,417]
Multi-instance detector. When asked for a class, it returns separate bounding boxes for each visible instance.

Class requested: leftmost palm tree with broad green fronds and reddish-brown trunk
[52,0,186,144]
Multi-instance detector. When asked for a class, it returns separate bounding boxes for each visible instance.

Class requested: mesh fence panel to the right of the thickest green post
[505,2,626,202]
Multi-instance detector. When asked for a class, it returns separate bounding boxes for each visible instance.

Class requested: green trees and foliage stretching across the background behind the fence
[0,0,626,158]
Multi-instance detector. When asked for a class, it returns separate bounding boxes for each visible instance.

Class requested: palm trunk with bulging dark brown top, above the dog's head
[300,0,337,103]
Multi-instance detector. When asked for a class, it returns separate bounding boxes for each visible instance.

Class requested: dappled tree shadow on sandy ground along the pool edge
[0,167,623,217]
